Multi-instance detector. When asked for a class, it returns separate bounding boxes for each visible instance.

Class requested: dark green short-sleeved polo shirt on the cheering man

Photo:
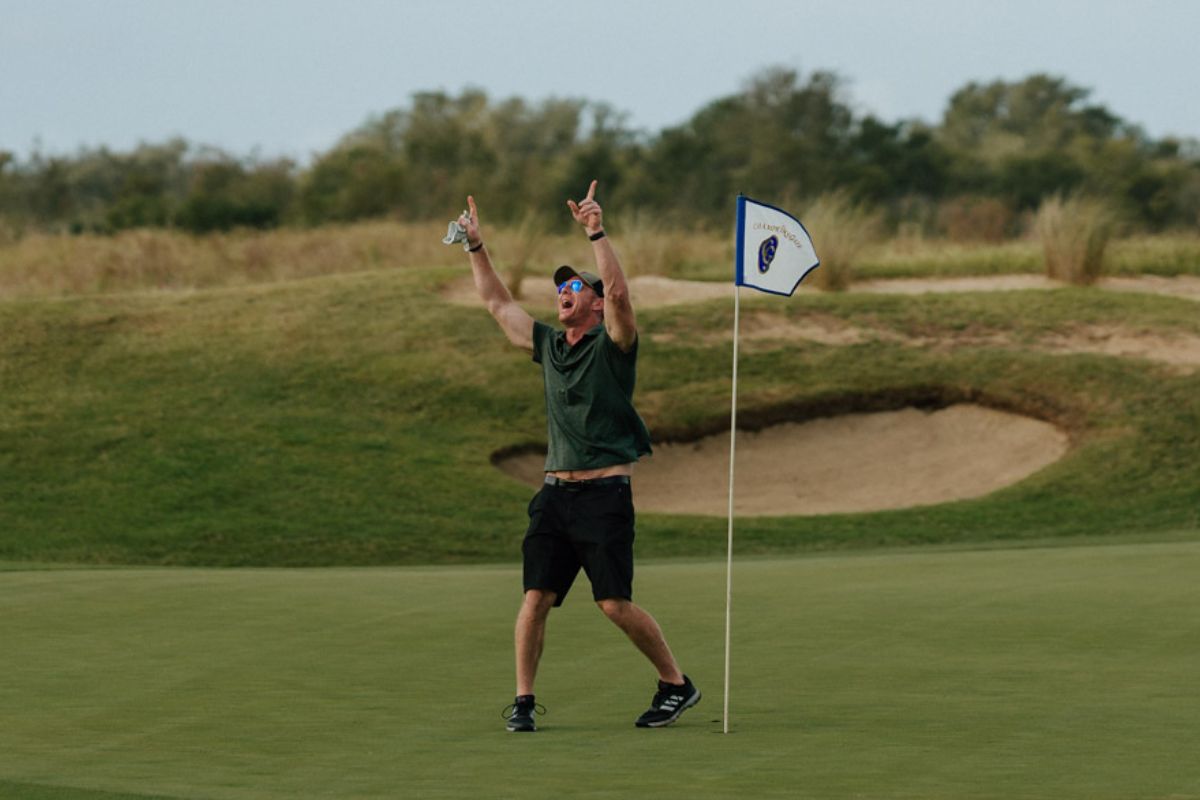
[533,321,650,473]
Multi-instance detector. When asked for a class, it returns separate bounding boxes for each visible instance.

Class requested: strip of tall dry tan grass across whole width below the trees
[0,212,1200,299]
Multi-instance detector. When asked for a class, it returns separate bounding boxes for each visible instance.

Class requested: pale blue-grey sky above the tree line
[0,0,1200,161]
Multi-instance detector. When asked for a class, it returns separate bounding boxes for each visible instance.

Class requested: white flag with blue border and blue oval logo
[734,194,821,295]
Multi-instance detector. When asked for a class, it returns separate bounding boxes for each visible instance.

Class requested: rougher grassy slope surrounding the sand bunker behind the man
[0,270,1200,566]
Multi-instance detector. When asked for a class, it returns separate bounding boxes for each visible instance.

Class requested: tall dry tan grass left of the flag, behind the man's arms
[0,215,732,297]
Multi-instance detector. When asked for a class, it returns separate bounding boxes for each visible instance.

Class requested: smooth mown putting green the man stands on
[0,539,1200,800]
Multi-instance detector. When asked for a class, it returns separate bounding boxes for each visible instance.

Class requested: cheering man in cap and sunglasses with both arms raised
[458,181,700,732]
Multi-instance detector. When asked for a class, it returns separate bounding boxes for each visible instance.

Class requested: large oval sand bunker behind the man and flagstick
[499,404,1068,516]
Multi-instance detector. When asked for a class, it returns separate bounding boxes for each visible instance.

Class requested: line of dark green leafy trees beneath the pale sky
[0,67,1200,237]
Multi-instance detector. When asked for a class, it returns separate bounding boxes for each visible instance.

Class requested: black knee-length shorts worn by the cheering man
[521,483,634,606]
